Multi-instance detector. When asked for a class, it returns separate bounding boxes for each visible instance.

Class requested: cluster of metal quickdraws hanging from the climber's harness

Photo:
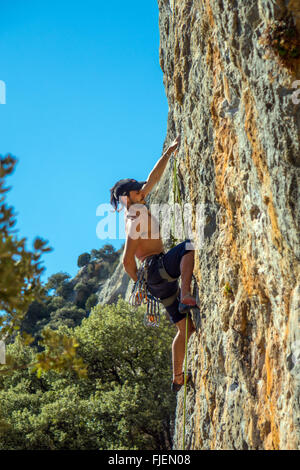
[129,264,160,326]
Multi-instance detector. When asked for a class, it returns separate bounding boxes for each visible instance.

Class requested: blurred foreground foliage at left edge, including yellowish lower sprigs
[0,155,88,414]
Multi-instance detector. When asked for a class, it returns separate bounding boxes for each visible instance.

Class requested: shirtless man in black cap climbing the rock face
[110,137,196,392]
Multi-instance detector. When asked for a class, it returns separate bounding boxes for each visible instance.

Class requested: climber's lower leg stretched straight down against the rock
[172,317,195,384]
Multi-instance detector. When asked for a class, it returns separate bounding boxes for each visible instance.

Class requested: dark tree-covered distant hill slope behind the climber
[20,244,124,346]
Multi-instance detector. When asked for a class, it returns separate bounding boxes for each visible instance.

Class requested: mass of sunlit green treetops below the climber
[0,299,175,450]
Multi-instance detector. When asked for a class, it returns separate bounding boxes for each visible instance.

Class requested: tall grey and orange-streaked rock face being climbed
[157,0,300,449]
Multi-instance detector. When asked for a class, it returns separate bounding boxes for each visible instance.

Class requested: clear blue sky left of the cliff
[0,0,168,281]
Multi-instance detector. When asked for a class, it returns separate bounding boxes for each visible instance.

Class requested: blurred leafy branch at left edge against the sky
[0,155,52,339]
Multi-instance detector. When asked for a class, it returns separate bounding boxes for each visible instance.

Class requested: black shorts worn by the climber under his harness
[147,239,193,323]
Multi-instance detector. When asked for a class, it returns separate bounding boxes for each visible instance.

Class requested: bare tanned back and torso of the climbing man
[125,204,164,261]
